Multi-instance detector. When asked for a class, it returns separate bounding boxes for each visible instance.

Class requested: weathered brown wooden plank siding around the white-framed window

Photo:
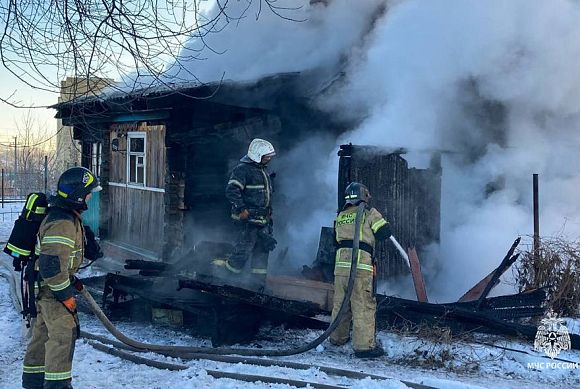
[108,123,166,257]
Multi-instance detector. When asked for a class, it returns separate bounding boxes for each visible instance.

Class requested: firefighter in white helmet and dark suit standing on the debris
[213,139,276,287]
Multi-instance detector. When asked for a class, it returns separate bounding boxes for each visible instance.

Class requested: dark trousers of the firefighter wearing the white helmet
[228,222,272,277]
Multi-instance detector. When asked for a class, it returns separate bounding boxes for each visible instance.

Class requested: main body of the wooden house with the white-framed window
[55,73,342,260]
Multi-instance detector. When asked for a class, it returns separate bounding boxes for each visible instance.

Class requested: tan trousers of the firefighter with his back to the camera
[330,270,377,351]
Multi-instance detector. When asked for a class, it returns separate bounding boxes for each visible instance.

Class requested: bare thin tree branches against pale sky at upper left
[0,0,299,107]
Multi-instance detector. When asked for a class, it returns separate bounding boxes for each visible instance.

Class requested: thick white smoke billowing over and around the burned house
[173,0,580,300]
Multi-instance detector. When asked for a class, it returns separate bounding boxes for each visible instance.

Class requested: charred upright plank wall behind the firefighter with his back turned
[338,145,441,279]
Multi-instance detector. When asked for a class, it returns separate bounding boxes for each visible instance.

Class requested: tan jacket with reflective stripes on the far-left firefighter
[35,207,84,301]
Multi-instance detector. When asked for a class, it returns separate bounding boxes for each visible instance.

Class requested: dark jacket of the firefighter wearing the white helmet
[226,156,272,224]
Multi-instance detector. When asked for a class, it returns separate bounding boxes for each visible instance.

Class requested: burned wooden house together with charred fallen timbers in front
[51,73,568,345]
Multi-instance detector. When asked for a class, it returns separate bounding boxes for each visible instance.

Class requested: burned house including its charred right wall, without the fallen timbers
[55,73,440,277]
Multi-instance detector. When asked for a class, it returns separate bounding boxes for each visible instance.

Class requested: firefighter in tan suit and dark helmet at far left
[22,167,101,389]
